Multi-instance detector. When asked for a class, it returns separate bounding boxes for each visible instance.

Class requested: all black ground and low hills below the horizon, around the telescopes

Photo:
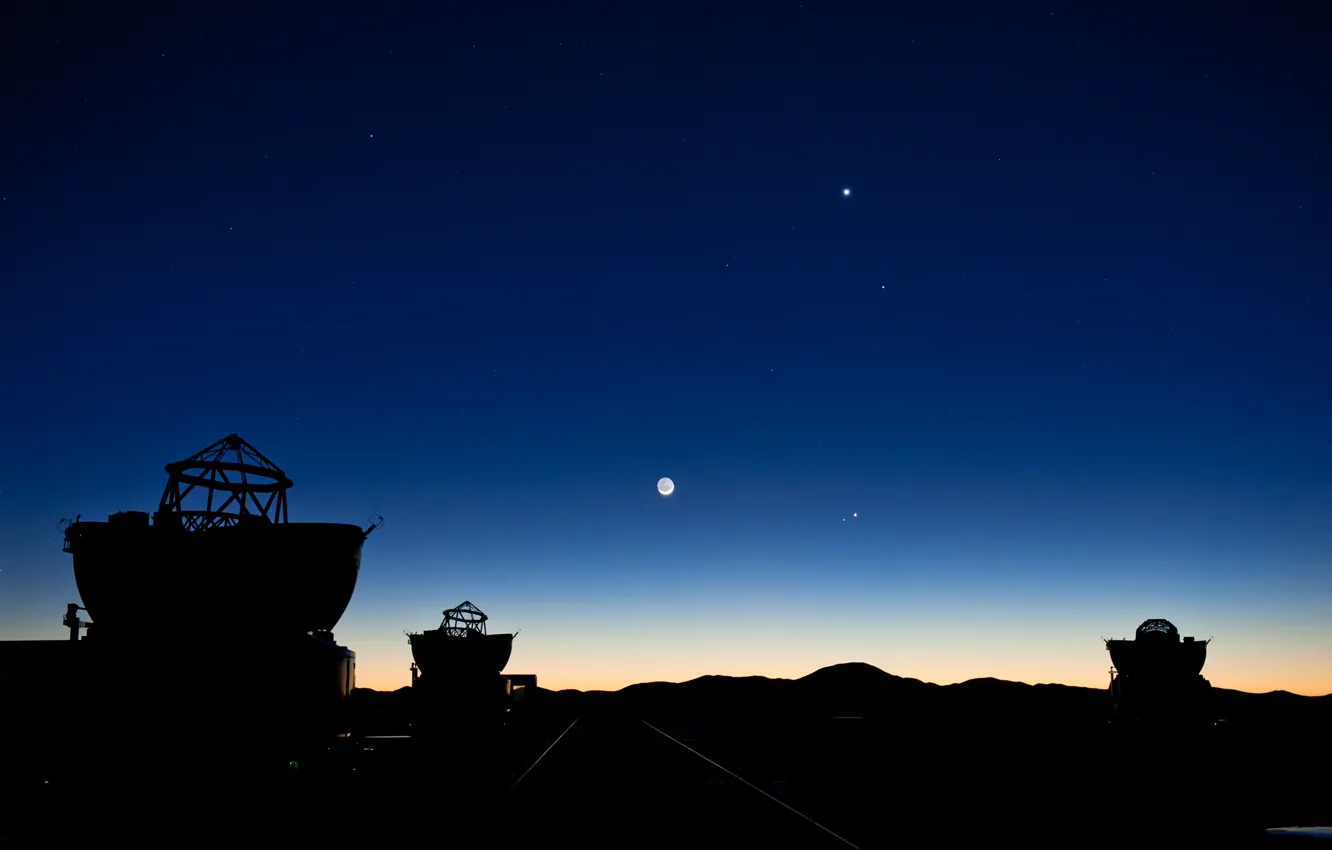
[0,665,1332,847]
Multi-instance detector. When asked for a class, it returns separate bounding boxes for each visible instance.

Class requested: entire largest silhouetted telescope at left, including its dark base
[0,434,382,795]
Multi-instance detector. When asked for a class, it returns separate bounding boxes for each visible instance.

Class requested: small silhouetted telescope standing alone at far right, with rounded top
[1106,620,1213,722]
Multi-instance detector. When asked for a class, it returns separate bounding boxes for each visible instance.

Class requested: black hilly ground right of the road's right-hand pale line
[500,665,1332,846]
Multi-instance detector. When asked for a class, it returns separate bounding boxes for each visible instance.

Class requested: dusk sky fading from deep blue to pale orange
[0,0,1332,693]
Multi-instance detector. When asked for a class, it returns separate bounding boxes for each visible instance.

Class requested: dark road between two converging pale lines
[484,717,856,850]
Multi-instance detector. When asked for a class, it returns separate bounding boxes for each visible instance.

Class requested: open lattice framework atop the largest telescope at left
[157,434,292,532]
